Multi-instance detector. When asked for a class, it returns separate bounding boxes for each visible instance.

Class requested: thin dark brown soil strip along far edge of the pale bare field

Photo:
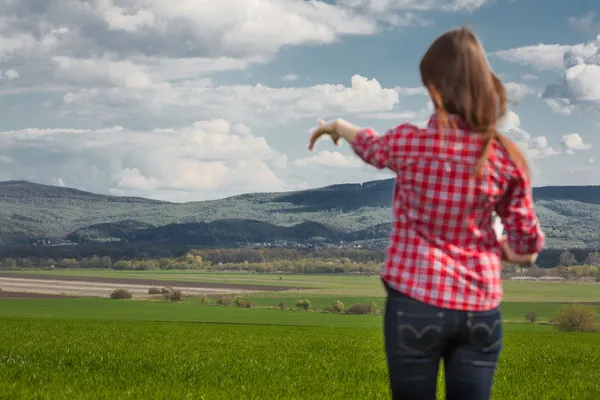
[0,273,302,292]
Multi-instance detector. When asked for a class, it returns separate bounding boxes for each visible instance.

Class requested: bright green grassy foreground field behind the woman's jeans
[0,318,600,400]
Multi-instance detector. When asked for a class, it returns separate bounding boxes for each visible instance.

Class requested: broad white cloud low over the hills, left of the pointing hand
[0,119,288,200]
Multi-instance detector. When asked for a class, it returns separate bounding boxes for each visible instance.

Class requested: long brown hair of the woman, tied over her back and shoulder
[420,27,529,176]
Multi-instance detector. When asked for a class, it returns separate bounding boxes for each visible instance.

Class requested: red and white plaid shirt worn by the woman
[352,115,544,311]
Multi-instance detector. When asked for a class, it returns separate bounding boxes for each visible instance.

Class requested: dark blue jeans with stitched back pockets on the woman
[384,288,503,400]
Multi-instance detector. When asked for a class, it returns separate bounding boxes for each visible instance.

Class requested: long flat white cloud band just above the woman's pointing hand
[58,75,399,123]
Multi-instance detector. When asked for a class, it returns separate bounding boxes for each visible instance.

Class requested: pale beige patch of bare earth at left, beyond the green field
[0,273,295,299]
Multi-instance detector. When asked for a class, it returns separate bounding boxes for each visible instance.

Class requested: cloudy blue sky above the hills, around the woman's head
[0,0,600,202]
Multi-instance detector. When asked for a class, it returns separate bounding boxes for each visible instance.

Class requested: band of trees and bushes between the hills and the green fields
[0,248,600,279]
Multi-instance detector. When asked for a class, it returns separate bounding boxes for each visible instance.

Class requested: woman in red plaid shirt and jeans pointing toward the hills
[309,28,544,400]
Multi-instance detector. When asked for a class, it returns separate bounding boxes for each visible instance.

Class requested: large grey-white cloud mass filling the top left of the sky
[0,0,485,97]
